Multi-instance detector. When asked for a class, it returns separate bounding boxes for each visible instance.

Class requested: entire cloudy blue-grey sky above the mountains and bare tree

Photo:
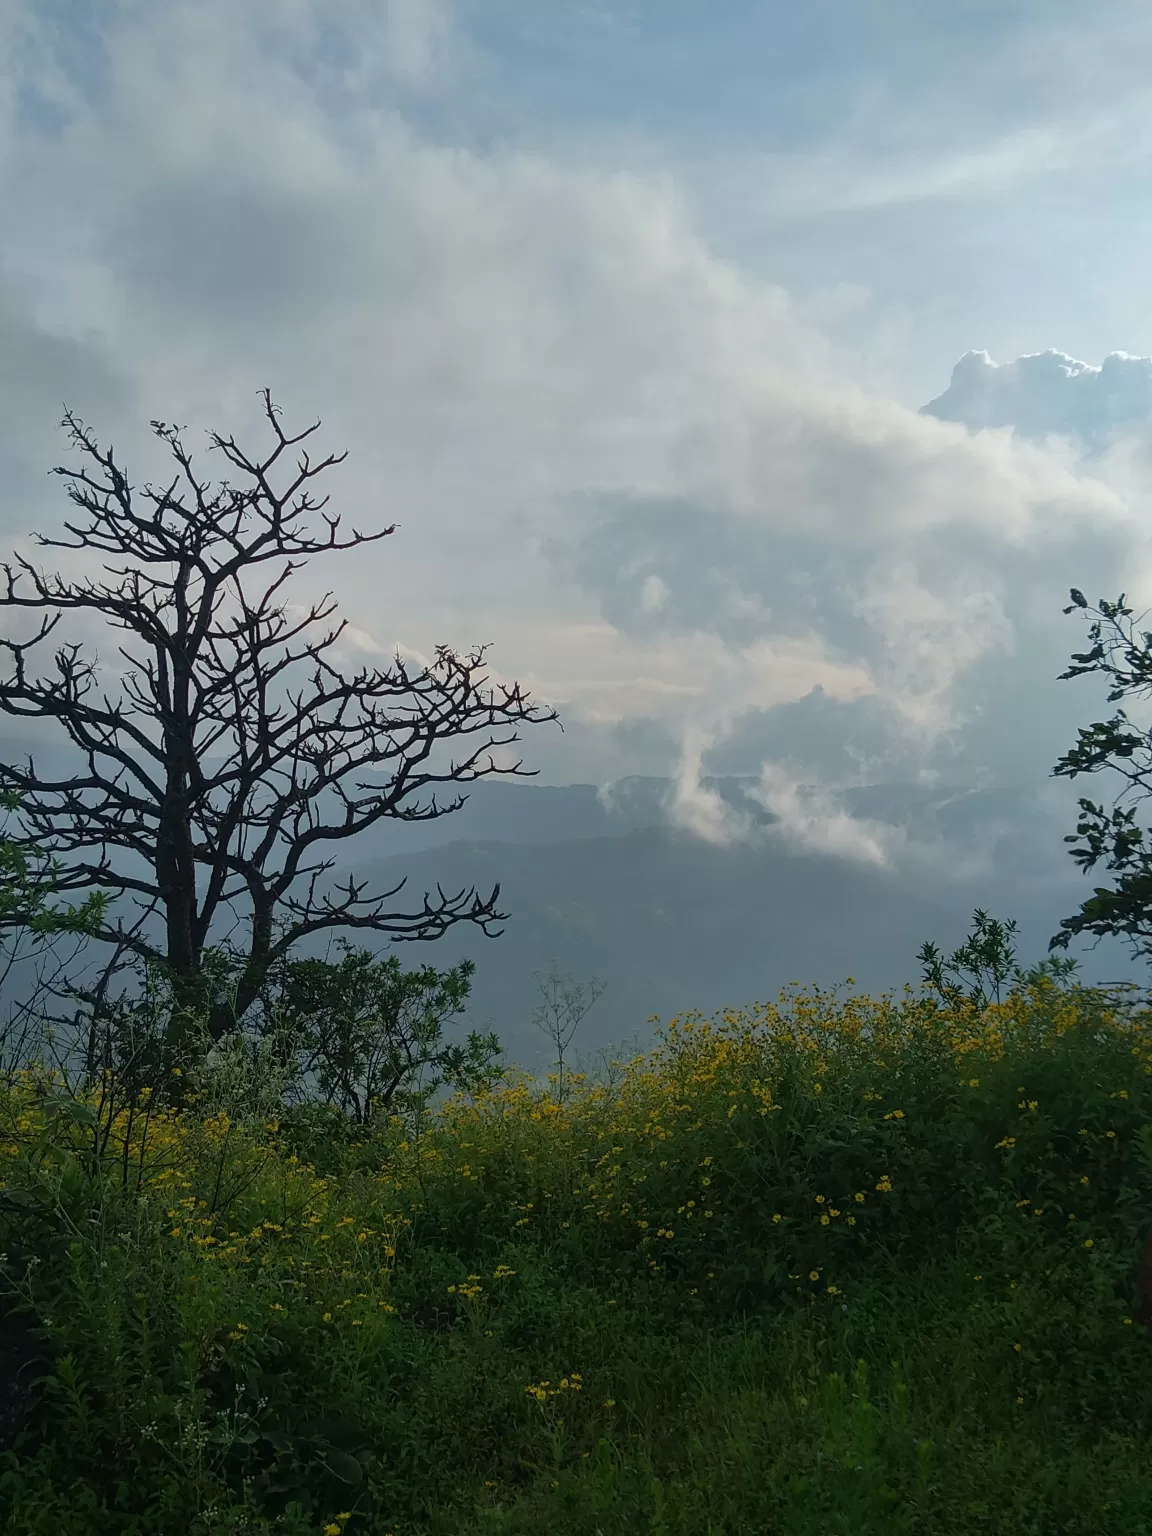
[0,0,1152,884]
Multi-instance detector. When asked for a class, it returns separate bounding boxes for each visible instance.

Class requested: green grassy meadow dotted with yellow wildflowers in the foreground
[0,982,1152,1536]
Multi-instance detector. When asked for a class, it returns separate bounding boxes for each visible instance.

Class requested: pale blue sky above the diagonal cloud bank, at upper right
[9,0,1152,404]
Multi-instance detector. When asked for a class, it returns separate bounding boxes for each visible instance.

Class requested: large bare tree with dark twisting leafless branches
[0,390,562,1075]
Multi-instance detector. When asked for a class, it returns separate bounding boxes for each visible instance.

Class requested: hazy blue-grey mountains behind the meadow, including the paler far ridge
[347,779,1146,1066]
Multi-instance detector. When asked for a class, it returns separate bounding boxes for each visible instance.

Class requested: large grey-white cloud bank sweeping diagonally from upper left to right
[0,0,1147,897]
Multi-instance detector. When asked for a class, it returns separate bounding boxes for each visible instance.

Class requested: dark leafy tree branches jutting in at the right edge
[1048,587,1152,955]
